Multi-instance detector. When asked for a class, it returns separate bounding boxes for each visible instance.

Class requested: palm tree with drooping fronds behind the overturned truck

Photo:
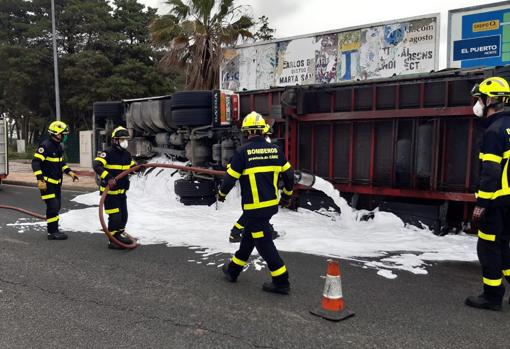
[150,0,254,90]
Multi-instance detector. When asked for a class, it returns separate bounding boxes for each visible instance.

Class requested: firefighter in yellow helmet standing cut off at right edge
[466,77,510,310]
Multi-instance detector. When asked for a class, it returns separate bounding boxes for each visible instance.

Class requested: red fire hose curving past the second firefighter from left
[99,163,225,250]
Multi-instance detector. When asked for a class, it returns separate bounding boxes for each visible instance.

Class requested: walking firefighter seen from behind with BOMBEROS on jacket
[218,112,294,294]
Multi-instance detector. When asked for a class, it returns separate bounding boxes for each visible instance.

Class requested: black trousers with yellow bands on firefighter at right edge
[477,207,510,303]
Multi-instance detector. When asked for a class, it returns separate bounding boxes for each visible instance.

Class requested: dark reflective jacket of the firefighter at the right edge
[476,112,510,207]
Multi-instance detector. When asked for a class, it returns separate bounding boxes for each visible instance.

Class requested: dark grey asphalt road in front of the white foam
[0,186,510,349]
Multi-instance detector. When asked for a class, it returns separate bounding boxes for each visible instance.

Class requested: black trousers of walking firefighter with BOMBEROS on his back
[228,215,289,284]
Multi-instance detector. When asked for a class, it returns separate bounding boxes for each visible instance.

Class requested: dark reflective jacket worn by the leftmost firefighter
[32,139,71,185]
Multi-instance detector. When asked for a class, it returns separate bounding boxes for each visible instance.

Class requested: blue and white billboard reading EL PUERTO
[447,1,510,68]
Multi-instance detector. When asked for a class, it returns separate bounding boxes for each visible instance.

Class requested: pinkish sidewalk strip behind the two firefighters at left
[3,159,98,191]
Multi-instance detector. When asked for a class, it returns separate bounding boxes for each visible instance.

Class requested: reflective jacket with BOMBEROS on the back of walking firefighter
[220,136,294,217]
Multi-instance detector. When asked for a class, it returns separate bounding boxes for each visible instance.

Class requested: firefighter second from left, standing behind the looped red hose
[94,126,136,249]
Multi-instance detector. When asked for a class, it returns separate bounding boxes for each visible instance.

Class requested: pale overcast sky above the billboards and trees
[139,0,504,68]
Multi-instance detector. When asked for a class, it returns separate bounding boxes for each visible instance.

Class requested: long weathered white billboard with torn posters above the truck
[220,14,439,90]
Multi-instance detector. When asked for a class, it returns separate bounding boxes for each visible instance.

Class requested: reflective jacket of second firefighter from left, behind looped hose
[94,145,136,195]
